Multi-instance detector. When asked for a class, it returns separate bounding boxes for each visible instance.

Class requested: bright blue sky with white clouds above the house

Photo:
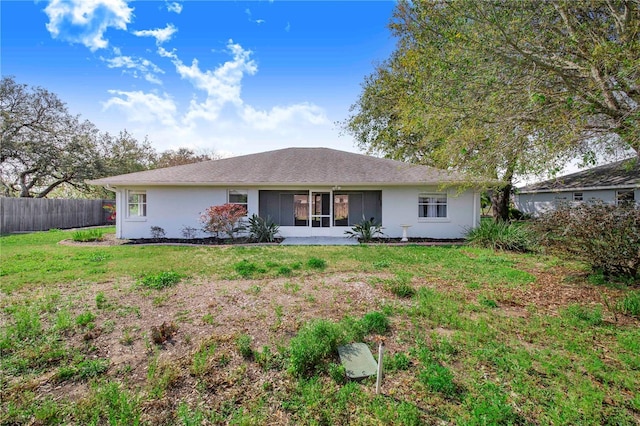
[0,0,395,155]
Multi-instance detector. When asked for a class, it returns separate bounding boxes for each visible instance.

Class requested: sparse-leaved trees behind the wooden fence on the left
[0,77,216,198]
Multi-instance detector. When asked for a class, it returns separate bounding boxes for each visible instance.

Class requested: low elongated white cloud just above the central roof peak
[241,103,330,130]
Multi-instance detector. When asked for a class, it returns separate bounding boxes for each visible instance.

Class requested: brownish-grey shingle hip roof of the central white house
[89,148,476,186]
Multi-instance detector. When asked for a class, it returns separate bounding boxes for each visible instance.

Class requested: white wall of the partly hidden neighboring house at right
[515,189,640,216]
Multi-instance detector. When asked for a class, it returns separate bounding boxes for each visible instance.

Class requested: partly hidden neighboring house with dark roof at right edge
[515,157,640,216]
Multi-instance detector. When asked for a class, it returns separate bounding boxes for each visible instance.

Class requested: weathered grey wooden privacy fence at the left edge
[0,197,115,234]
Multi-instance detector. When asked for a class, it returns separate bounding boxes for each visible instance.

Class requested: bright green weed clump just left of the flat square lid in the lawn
[289,320,344,377]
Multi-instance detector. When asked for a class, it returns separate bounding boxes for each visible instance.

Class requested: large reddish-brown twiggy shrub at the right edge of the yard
[536,202,640,279]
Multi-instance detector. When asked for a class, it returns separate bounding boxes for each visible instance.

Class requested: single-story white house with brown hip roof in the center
[89,148,480,238]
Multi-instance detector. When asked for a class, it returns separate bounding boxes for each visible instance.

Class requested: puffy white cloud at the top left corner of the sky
[44,0,133,52]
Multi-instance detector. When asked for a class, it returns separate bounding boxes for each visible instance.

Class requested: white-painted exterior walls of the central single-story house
[116,186,480,239]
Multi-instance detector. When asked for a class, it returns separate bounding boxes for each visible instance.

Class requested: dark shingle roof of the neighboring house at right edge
[519,157,640,193]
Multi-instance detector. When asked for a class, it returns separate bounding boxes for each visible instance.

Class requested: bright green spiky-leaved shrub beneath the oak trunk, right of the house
[466,220,536,253]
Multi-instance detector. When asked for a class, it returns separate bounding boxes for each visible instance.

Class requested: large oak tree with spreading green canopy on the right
[343,0,640,218]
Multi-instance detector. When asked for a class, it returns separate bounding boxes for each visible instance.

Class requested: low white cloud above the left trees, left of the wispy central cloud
[102,90,176,126]
